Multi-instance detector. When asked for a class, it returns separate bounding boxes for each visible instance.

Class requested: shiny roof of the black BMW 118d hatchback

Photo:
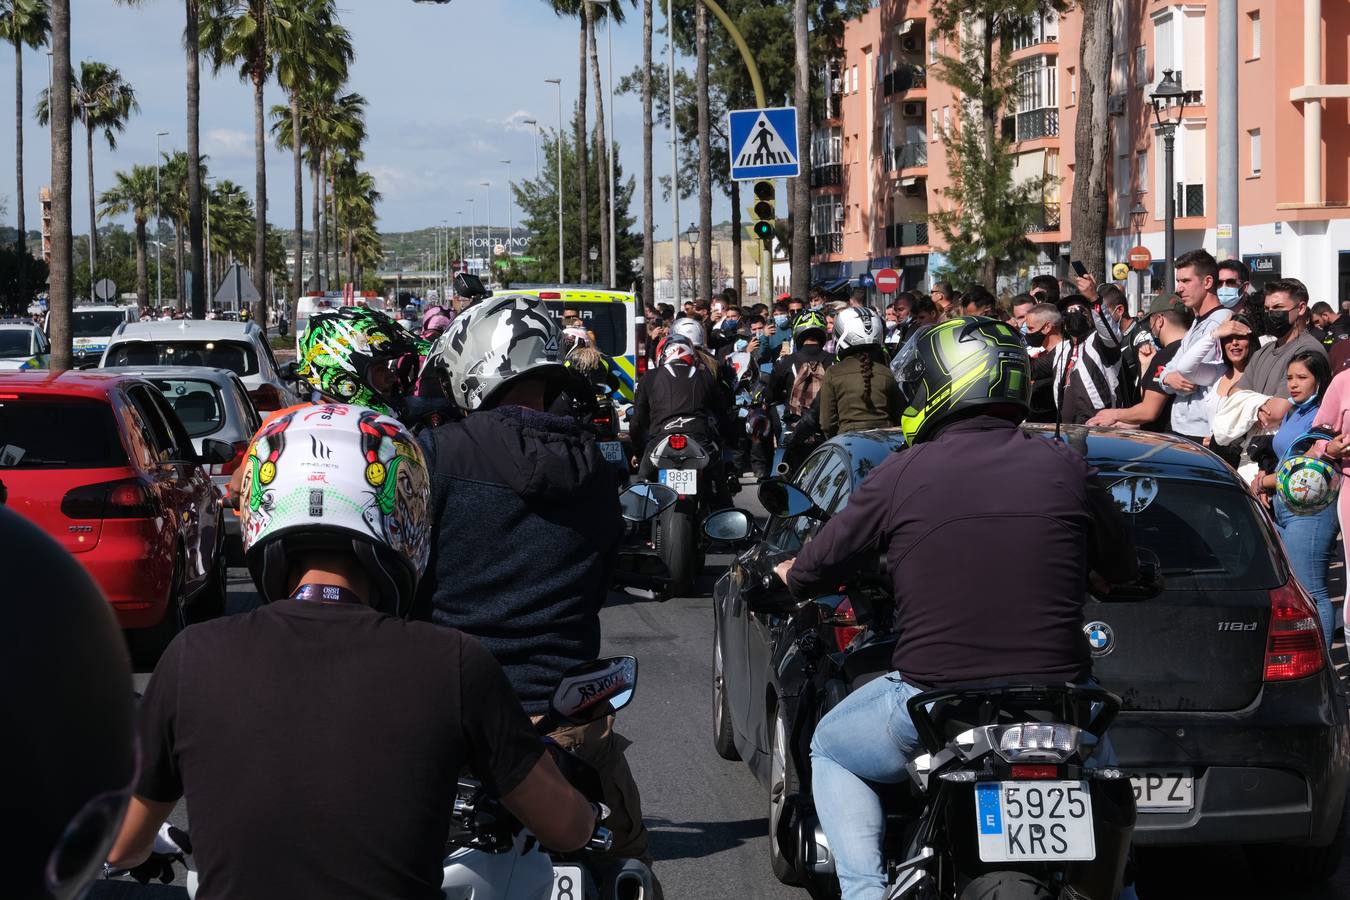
[830,424,1242,487]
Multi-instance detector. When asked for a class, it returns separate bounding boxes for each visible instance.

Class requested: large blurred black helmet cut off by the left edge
[0,509,136,900]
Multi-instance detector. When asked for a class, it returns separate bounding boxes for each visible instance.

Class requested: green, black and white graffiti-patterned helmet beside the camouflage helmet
[296,306,425,413]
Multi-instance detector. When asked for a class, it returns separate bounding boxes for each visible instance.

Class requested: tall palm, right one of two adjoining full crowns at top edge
[273,0,354,313]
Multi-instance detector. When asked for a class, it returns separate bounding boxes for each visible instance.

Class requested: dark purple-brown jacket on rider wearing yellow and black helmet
[787,416,1137,688]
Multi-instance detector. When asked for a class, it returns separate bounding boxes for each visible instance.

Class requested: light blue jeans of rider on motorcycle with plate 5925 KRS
[811,672,1135,900]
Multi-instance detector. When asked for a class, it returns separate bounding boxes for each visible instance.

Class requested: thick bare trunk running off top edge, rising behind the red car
[49,0,72,372]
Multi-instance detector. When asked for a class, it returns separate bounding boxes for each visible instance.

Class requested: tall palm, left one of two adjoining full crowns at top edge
[201,0,313,322]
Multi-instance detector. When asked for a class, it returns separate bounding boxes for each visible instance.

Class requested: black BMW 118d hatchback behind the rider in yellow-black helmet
[713,426,1350,884]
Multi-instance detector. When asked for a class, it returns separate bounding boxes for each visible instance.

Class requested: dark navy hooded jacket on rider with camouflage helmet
[419,406,624,715]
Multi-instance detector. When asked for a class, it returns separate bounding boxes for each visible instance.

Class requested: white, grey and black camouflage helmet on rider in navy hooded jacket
[428,294,563,413]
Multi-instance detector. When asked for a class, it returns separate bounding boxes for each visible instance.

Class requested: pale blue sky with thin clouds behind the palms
[0,0,729,246]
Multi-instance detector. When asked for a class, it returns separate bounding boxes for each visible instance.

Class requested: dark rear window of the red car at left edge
[0,395,127,470]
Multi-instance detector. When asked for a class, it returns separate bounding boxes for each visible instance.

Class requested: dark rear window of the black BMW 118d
[1102,474,1280,591]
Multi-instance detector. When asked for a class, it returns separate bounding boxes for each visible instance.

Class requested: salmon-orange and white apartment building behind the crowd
[810,0,1350,301]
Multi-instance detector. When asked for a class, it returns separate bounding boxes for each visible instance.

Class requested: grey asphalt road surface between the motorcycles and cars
[89,491,1350,900]
